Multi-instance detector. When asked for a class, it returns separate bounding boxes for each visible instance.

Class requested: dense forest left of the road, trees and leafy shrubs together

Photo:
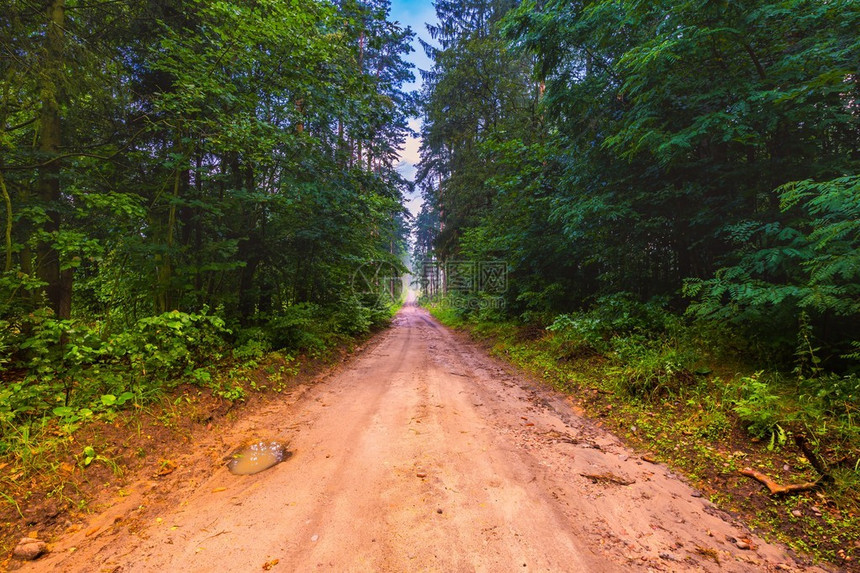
[0,0,416,428]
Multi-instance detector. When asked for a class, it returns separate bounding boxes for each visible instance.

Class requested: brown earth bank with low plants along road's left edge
[0,306,396,552]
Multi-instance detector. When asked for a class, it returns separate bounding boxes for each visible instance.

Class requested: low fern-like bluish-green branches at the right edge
[685,177,860,369]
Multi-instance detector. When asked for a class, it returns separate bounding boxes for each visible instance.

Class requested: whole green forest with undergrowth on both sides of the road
[0,0,860,559]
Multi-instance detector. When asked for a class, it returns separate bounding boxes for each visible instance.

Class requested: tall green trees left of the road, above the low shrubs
[0,0,415,322]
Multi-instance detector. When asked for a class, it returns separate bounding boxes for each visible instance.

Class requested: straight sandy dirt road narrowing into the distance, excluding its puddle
[22,306,828,572]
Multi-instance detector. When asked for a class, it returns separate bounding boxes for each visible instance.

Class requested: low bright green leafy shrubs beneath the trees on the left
[0,311,229,433]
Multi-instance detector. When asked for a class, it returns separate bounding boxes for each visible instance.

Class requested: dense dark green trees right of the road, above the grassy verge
[418,1,860,369]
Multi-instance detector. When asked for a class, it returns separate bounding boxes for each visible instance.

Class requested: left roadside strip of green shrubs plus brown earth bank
[0,303,404,549]
